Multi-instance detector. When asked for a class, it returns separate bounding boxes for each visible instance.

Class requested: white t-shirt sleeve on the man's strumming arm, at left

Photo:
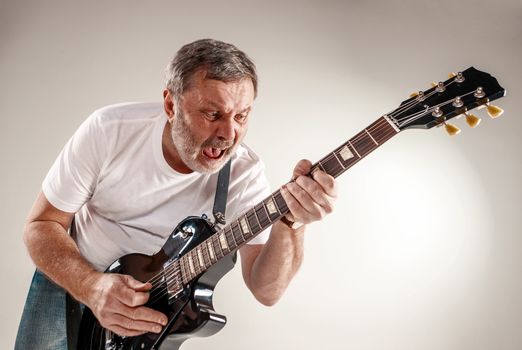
[42,112,106,213]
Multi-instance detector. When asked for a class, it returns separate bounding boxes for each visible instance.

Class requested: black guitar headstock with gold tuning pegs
[387,67,506,135]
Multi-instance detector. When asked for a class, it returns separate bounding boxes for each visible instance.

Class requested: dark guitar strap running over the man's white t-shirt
[65,159,232,350]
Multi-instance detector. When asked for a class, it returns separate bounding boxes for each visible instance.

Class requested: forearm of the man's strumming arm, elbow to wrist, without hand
[24,221,99,303]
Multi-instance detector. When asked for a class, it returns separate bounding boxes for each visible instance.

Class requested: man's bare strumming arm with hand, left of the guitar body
[24,192,167,335]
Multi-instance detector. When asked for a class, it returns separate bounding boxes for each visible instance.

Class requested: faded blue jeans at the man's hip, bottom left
[15,270,79,350]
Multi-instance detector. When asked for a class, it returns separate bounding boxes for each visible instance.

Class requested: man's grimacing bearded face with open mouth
[165,73,254,173]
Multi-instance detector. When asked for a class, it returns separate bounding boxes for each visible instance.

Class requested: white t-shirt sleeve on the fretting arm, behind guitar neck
[242,162,270,244]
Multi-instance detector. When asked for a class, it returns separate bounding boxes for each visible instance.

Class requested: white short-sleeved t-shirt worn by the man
[42,103,270,271]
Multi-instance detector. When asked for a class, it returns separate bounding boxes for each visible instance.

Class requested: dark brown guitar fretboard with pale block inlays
[179,117,399,283]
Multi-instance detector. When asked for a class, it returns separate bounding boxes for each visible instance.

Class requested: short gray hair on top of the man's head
[166,39,257,99]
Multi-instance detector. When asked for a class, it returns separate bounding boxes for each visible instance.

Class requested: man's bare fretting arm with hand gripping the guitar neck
[240,160,337,306]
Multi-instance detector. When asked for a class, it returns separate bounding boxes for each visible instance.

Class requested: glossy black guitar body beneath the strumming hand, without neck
[77,217,236,350]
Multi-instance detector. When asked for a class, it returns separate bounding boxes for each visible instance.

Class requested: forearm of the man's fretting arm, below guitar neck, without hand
[245,222,304,305]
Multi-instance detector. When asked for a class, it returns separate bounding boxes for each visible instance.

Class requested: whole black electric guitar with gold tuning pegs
[78,67,506,350]
